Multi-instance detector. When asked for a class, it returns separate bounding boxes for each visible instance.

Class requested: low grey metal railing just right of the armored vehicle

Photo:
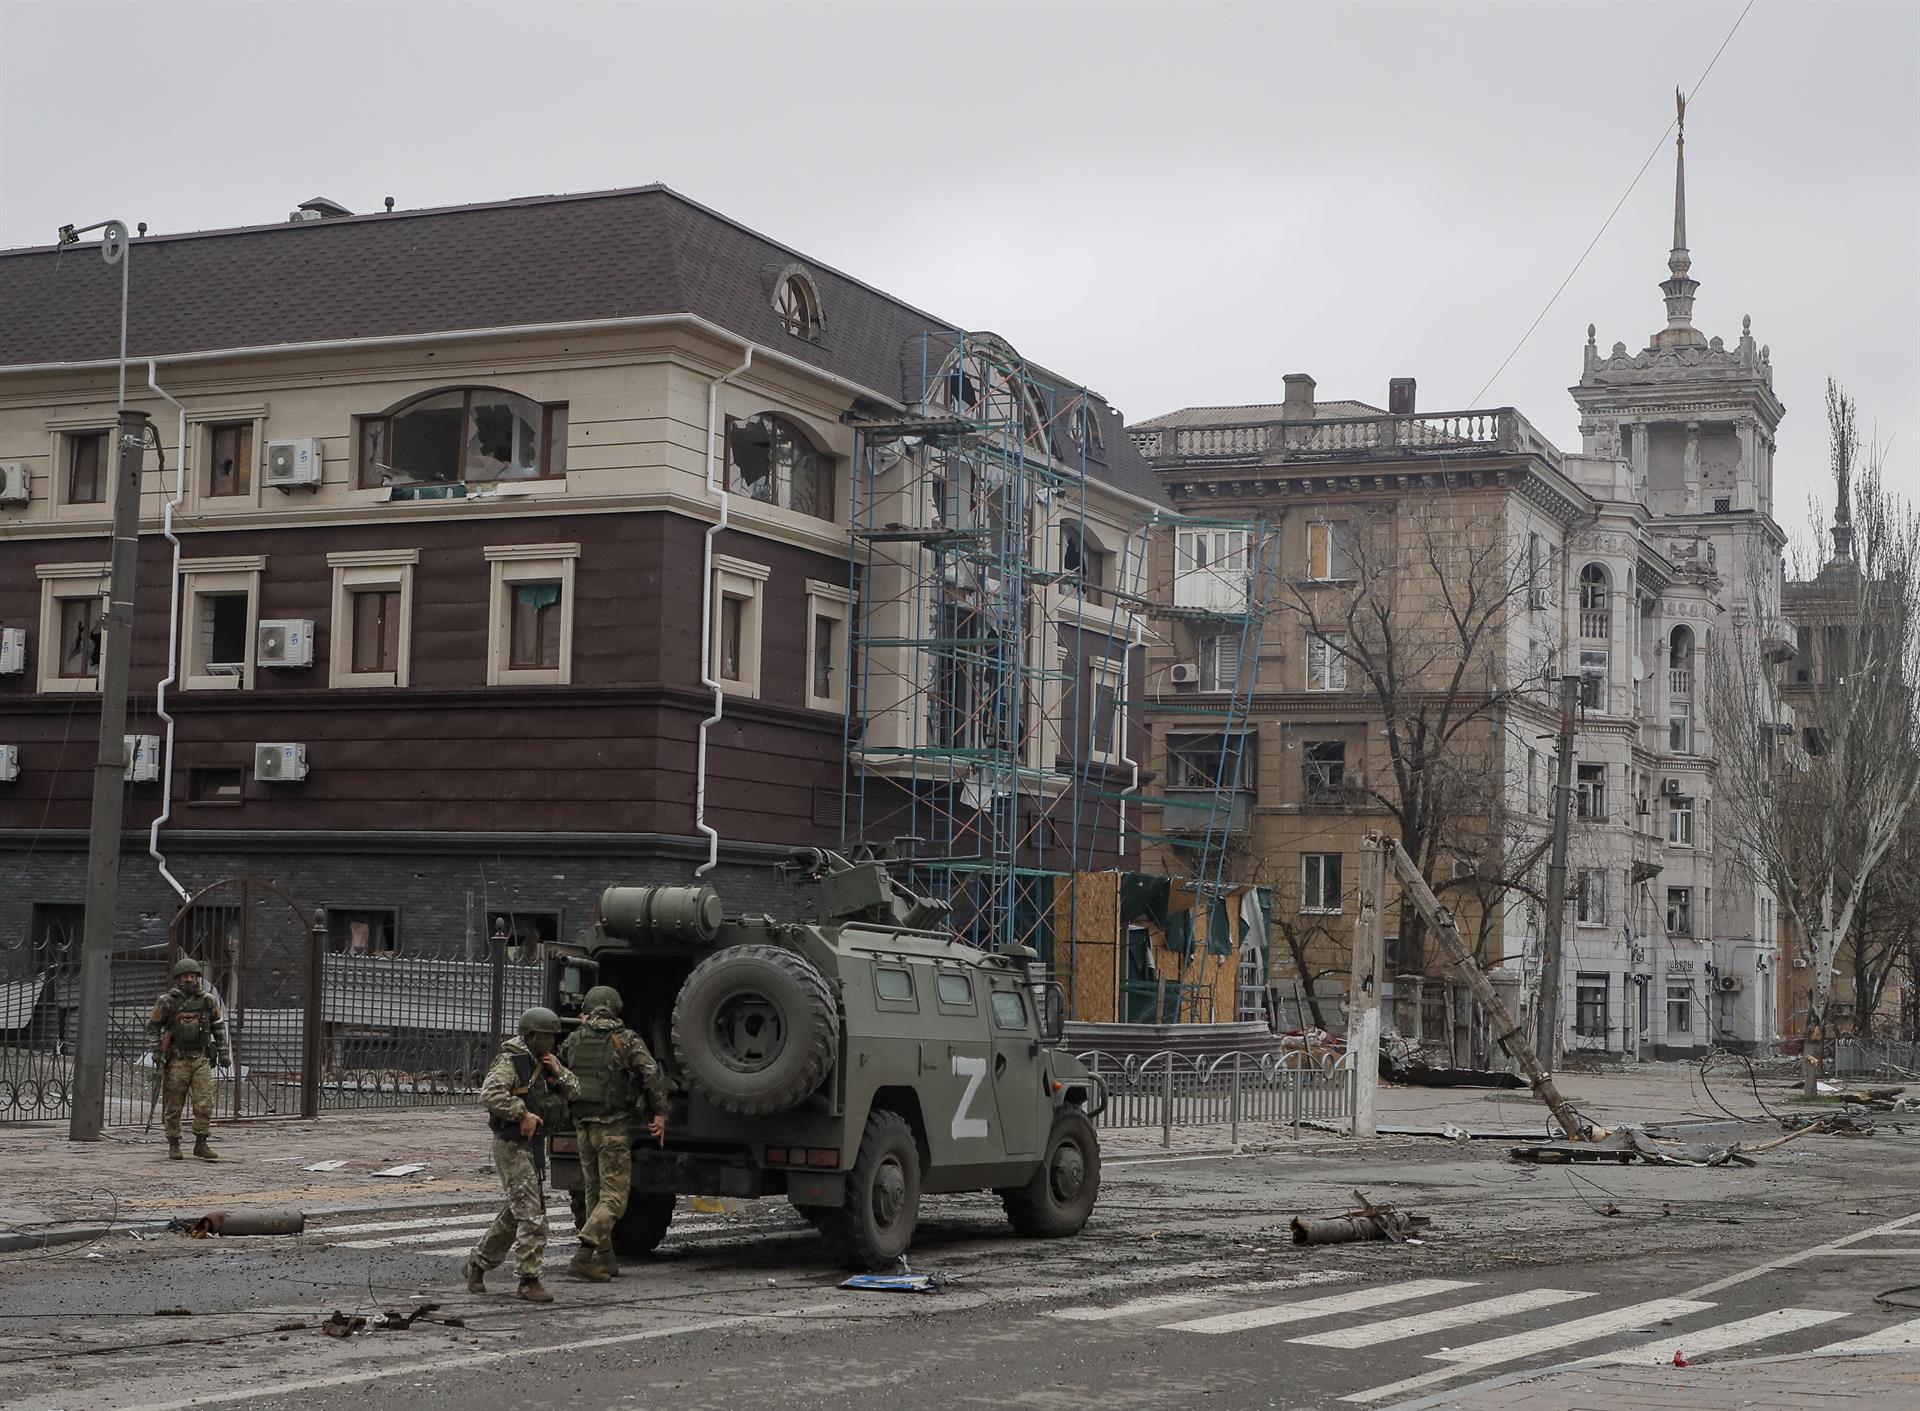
[1079,1050,1354,1146]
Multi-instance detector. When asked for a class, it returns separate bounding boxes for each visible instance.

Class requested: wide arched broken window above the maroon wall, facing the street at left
[359,388,566,490]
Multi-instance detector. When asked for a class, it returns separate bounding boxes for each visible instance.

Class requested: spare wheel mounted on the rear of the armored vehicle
[674,946,839,1117]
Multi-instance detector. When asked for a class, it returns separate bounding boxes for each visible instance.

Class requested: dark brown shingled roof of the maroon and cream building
[0,186,1165,503]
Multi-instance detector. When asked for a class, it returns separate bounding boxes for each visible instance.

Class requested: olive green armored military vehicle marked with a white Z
[547,849,1104,1269]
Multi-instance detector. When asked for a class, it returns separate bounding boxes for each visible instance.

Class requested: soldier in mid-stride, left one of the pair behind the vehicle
[461,1004,580,1303]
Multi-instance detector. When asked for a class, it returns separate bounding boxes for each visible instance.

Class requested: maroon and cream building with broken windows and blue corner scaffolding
[0,188,1165,956]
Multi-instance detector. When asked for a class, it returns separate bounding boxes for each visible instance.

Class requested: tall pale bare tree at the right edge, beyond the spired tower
[1705,382,1920,1092]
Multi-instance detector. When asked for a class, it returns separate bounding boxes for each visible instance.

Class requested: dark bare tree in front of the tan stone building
[1279,493,1540,973]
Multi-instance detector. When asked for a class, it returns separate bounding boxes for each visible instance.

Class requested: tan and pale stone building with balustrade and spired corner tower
[1135,113,1795,1060]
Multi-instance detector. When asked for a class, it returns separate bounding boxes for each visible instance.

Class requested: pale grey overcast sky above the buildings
[0,0,1920,530]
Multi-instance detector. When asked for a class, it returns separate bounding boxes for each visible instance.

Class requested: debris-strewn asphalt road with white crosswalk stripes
[0,1127,1920,1411]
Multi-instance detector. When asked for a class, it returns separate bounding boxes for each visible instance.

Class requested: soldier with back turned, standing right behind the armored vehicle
[561,985,666,1284]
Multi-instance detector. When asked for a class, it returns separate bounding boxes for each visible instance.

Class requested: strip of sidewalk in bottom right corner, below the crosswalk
[1392,1351,1920,1411]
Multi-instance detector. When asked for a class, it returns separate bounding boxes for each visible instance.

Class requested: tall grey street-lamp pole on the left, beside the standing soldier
[60,221,148,1142]
